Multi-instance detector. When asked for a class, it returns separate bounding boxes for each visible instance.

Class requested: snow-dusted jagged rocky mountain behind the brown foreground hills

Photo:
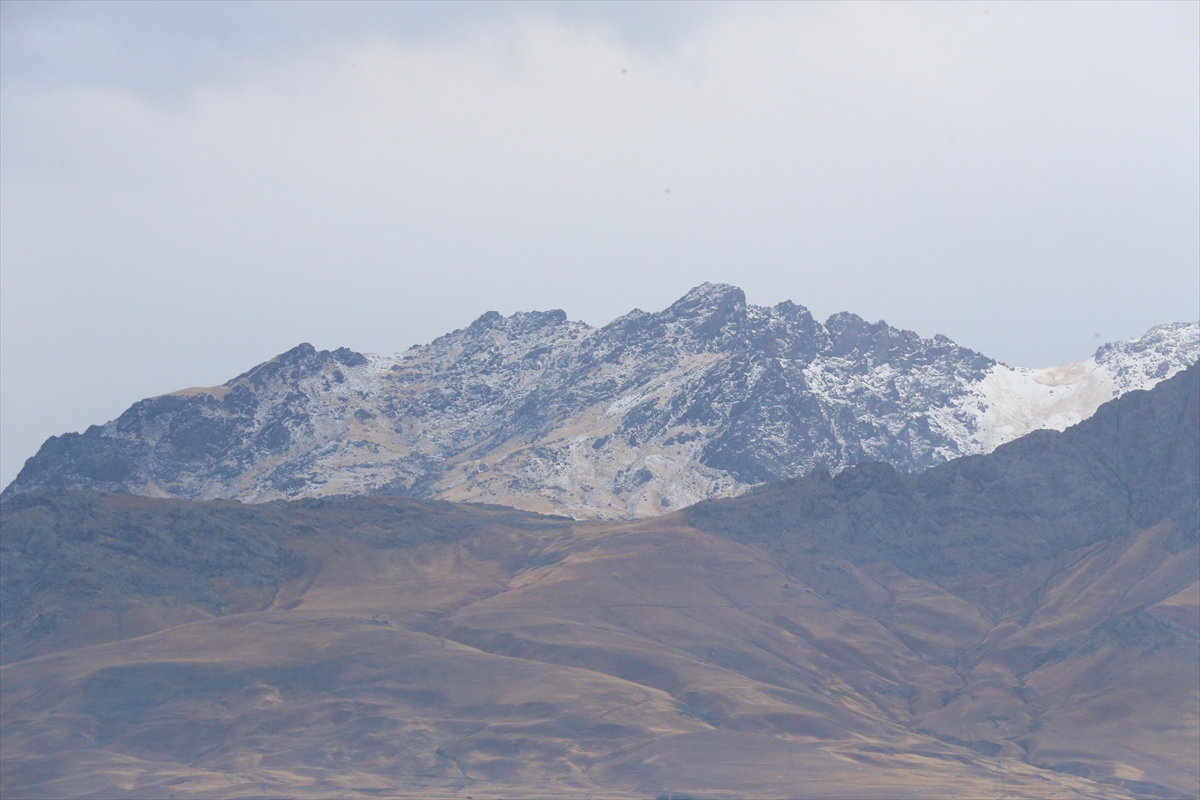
[0,283,1200,518]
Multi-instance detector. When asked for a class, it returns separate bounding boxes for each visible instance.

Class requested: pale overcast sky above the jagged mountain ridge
[0,0,1200,485]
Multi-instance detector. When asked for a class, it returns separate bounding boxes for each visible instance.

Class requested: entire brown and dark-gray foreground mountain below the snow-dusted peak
[0,366,1200,799]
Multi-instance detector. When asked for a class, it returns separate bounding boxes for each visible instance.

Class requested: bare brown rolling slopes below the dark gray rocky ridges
[0,495,1200,800]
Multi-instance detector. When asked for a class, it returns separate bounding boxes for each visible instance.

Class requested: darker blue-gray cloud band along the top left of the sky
[0,0,731,103]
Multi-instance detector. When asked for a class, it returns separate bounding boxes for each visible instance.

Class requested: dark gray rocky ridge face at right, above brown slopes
[688,365,1200,582]
